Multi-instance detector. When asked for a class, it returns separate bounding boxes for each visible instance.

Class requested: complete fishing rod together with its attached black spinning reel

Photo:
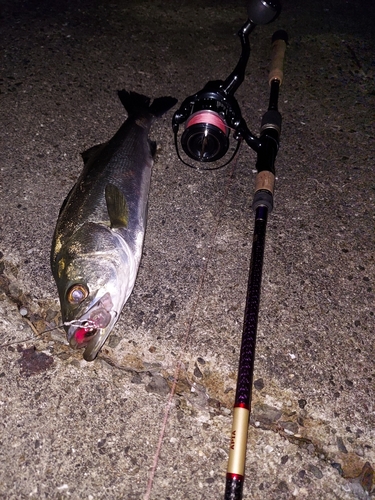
[172,0,288,500]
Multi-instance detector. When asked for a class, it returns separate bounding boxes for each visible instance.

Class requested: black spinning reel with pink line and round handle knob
[172,0,281,170]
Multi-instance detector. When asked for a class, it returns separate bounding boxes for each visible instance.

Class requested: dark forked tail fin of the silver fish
[118,90,177,117]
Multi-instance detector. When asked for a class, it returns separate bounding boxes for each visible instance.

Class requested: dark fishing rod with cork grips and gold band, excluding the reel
[224,30,287,500]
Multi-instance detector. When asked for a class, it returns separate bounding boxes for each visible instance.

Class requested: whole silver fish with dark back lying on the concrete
[51,90,177,361]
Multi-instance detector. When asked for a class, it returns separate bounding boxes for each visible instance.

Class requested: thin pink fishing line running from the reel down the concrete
[143,141,242,500]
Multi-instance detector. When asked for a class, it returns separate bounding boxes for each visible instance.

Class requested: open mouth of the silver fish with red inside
[68,293,117,361]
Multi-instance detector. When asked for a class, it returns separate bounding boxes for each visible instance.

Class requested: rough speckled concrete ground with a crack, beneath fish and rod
[0,0,375,500]
